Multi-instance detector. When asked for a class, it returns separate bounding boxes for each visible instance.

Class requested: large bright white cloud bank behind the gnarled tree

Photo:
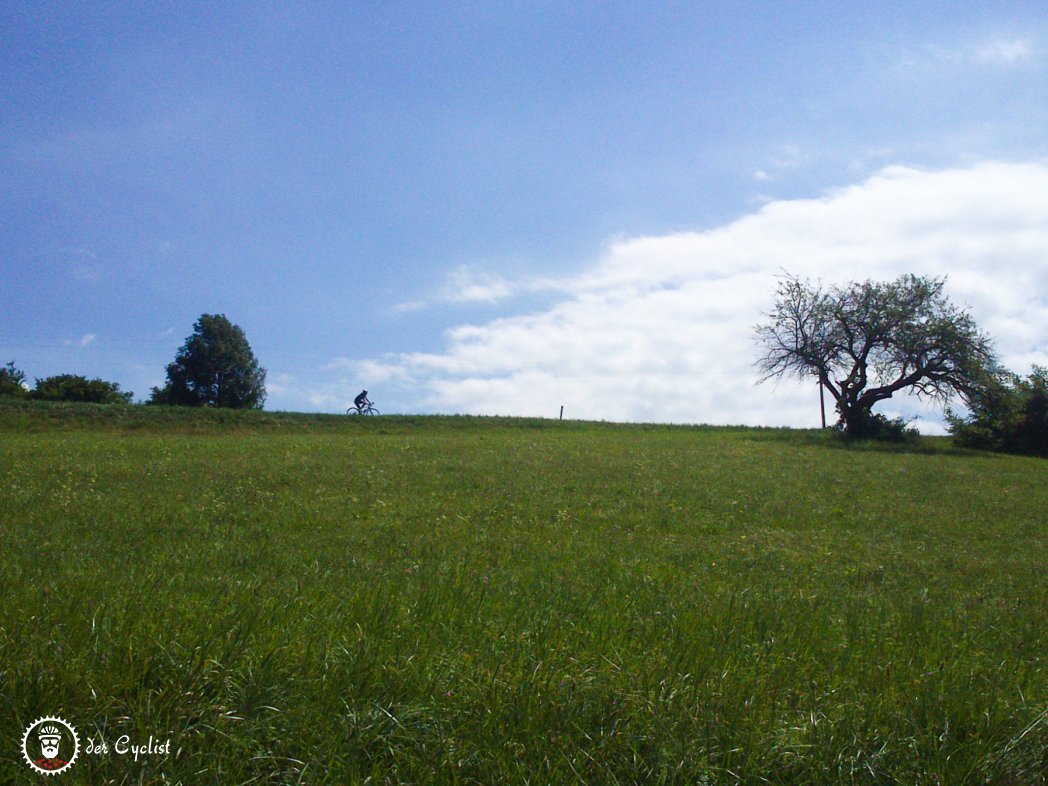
[357,163,1048,430]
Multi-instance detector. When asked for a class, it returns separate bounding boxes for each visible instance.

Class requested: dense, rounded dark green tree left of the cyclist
[150,313,265,409]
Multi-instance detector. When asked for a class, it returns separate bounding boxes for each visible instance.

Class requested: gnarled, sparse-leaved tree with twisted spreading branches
[756,276,998,437]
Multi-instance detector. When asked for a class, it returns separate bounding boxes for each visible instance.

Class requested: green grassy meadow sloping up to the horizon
[0,405,1048,786]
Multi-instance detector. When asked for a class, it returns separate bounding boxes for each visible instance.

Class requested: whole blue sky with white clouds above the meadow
[0,2,1048,425]
